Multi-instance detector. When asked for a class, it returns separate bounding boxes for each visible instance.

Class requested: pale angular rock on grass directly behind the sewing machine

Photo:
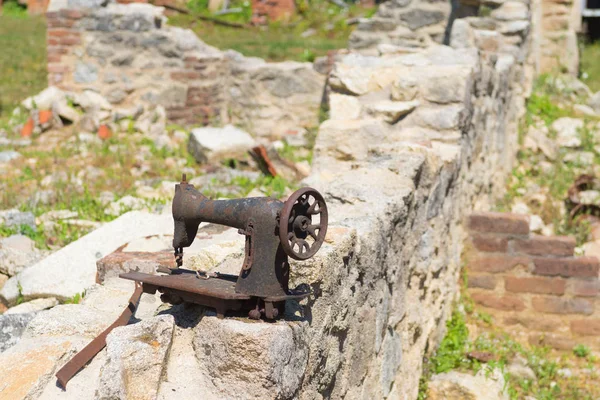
[188,125,256,163]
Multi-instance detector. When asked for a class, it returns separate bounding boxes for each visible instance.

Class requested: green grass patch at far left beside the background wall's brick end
[0,13,47,119]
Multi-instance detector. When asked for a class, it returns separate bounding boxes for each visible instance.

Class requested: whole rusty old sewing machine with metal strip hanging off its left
[56,174,327,388]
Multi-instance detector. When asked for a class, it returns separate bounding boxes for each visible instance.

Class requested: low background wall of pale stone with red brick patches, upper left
[47,0,325,137]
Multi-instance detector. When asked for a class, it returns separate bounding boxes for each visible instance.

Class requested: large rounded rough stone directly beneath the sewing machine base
[194,316,308,399]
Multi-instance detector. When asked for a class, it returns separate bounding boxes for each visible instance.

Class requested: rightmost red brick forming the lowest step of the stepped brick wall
[533,257,600,278]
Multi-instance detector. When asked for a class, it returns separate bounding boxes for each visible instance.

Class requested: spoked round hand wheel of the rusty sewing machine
[279,187,327,260]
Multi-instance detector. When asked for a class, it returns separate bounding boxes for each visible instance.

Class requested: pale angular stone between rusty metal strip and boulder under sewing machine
[96,315,175,399]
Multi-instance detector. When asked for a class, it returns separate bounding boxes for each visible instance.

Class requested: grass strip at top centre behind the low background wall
[164,1,374,61]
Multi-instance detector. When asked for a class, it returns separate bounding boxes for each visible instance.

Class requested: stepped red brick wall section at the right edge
[467,213,600,351]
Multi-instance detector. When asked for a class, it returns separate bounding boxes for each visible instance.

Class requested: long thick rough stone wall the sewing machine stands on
[0,1,564,400]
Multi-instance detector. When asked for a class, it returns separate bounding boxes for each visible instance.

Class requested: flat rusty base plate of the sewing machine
[119,271,310,319]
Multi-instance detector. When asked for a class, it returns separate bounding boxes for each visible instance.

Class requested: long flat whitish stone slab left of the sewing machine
[0,211,173,304]
